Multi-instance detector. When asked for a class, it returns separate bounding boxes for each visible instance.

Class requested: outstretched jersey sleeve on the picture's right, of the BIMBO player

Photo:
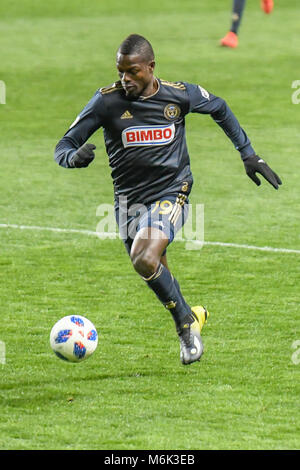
[185,83,255,159]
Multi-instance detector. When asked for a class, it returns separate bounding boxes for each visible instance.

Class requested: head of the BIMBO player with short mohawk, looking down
[117,34,155,98]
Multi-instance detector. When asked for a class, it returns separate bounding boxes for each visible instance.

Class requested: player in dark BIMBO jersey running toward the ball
[55,34,281,364]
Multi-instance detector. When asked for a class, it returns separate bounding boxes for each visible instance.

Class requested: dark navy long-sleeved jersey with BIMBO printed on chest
[55,79,255,204]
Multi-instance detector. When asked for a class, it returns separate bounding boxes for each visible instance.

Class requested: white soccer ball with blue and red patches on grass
[50,315,98,362]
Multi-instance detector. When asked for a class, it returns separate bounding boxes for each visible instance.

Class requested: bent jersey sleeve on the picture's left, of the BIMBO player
[54,90,106,168]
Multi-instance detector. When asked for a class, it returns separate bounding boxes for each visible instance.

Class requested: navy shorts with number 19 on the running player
[115,193,188,253]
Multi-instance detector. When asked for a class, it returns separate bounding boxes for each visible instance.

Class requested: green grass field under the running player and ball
[0,0,300,450]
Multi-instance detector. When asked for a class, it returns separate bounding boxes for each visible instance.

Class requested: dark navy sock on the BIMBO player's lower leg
[145,264,193,328]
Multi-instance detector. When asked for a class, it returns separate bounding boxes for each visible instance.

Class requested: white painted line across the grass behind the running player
[0,224,300,255]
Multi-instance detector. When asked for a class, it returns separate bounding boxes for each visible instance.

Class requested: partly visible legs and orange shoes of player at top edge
[220,0,274,48]
